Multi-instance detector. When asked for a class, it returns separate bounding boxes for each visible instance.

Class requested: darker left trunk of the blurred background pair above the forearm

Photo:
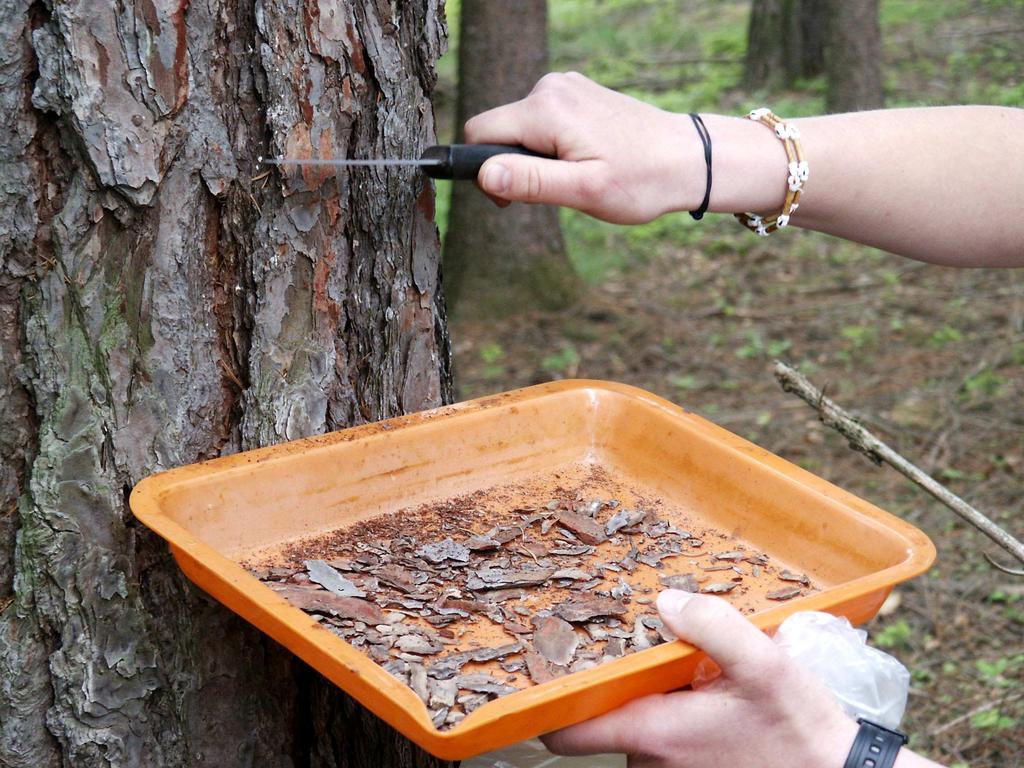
[743,0,827,90]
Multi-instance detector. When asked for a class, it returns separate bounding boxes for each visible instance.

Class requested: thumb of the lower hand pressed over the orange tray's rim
[657,590,781,682]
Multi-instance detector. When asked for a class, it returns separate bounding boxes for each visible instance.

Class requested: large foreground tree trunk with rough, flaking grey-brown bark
[0,0,451,768]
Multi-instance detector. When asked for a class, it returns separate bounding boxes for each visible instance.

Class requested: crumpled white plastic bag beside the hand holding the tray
[775,610,910,728]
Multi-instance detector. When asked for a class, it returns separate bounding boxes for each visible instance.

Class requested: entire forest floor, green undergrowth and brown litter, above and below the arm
[439,0,1024,768]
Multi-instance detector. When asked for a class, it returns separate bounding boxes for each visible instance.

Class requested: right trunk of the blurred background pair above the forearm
[826,0,885,112]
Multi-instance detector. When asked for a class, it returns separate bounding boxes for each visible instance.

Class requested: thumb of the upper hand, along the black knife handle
[477,155,603,209]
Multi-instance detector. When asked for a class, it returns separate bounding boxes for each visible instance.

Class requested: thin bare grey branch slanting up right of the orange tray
[775,360,1024,575]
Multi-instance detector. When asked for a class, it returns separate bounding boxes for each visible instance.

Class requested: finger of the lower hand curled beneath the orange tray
[541,694,666,755]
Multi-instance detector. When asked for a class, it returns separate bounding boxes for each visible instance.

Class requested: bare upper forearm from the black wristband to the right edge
[680,106,1024,266]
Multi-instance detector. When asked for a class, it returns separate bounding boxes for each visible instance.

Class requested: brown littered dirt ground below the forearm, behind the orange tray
[452,237,1024,768]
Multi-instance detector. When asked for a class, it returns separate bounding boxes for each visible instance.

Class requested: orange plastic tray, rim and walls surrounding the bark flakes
[131,381,935,760]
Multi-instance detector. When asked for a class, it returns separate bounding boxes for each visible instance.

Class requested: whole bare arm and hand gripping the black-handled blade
[465,73,1024,266]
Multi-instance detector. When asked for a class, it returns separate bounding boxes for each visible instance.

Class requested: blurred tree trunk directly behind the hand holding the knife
[444,0,579,316]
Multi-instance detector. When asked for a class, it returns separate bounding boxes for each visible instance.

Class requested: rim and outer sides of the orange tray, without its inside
[129,379,935,760]
